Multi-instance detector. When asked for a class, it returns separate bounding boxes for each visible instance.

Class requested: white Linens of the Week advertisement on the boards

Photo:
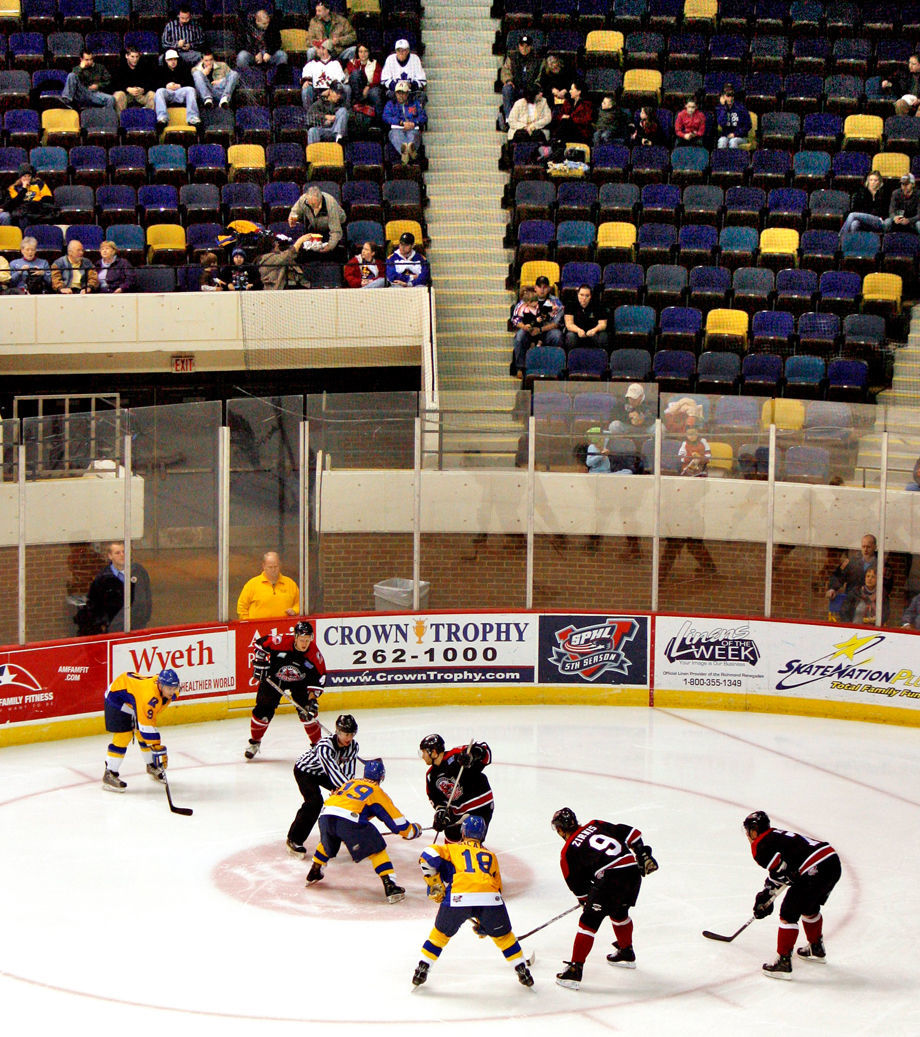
[654,616,775,695]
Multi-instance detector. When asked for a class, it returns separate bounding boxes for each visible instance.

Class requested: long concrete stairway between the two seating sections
[423,0,520,465]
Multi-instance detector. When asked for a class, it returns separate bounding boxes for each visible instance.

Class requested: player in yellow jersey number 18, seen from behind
[412,814,533,986]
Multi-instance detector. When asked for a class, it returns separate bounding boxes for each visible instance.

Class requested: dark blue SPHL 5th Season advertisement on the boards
[538,614,649,688]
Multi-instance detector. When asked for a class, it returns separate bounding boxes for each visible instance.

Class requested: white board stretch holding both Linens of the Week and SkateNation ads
[654,616,920,708]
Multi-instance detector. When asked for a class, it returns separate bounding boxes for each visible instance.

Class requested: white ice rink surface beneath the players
[0,706,920,1037]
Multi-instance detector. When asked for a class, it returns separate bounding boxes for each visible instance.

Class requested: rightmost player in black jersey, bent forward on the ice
[744,810,840,979]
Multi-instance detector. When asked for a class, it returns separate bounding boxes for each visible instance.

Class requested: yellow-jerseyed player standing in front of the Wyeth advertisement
[103,670,179,792]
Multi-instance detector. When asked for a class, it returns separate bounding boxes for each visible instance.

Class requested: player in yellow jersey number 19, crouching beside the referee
[307,760,422,904]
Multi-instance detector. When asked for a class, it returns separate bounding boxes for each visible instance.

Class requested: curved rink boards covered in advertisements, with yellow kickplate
[0,612,920,745]
